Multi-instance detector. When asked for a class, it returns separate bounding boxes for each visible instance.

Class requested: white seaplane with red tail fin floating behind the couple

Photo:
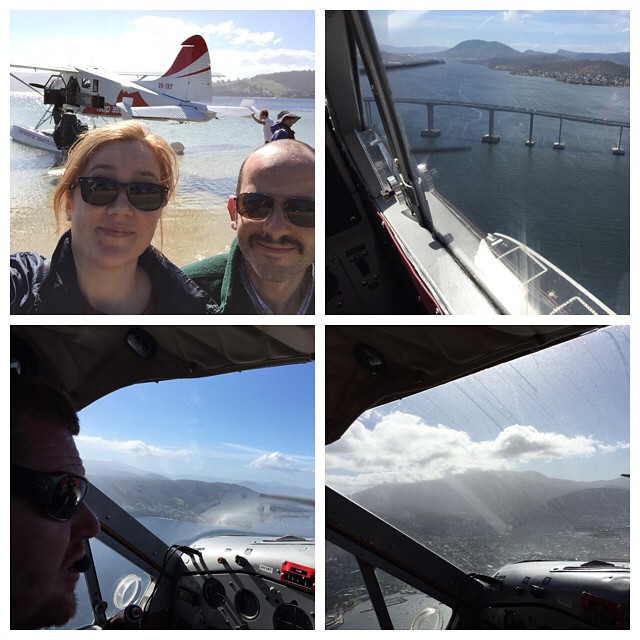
[11,35,253,151]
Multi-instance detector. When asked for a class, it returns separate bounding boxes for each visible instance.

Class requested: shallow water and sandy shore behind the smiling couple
[10,92,315,266]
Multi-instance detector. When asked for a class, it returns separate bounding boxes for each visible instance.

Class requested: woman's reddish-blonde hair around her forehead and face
[53,120,178,231]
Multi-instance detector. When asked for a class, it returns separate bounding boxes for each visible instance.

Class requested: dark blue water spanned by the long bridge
[370,63,631,313]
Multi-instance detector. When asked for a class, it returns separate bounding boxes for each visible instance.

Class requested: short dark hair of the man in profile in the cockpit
[10,376,80,461]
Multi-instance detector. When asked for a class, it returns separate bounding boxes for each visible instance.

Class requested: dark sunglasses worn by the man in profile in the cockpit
[11,464,89,522]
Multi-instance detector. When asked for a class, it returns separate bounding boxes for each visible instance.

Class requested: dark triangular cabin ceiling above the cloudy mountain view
[325,325,595,444]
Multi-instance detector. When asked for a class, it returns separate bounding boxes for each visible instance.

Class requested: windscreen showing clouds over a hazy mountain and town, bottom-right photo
[325,326,630,628]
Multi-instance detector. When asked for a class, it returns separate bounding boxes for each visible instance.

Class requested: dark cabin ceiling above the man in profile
[11,325,315,410]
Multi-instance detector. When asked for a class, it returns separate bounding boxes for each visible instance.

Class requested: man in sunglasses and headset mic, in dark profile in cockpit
[9,377,100,629]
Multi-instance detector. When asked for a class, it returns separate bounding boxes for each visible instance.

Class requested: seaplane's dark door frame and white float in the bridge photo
[325,10,614,315]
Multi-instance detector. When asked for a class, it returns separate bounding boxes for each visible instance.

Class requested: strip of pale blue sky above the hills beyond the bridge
[371,10,630,53]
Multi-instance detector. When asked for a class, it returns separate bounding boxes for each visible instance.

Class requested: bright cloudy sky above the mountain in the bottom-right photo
[325,326,630,493]
